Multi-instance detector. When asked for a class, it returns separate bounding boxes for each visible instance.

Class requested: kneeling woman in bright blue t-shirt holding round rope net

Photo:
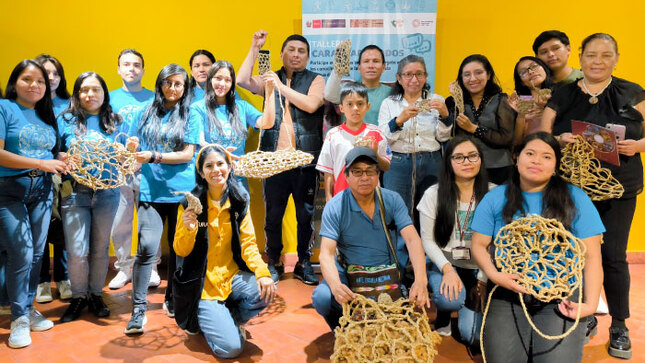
[472,132,605,362]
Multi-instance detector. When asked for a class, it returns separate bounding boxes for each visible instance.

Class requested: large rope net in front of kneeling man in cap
[331,294,441,363]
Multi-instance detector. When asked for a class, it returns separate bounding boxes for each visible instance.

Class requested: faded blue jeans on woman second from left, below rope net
[61,182,119,298]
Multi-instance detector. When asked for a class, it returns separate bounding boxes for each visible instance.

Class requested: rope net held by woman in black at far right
[560,135,625,201]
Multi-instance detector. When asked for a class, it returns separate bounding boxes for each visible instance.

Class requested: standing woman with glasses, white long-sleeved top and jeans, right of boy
[379,54,451,215]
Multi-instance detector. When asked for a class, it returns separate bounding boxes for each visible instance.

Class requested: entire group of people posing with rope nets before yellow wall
[0,31,645,361]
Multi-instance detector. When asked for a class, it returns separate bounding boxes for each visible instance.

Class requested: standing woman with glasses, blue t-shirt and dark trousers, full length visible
[125,64,200,334]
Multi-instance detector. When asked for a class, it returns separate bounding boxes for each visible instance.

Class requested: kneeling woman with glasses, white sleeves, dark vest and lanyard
[417,135,494,354]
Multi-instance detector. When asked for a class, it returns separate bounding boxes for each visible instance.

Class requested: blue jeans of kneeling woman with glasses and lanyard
[428,263,482,345]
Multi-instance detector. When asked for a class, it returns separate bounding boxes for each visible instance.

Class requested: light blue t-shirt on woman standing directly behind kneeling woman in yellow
[190,99,262,156]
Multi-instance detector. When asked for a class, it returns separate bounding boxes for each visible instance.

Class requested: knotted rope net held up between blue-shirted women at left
[67,133,138,190]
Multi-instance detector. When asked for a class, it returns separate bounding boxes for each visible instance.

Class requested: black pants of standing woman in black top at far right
[594,197,636,320]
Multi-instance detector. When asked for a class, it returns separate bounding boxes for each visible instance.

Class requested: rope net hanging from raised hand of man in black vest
[235,83,314,179]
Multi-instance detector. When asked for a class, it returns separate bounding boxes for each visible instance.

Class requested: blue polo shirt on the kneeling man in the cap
[320,188,412,266]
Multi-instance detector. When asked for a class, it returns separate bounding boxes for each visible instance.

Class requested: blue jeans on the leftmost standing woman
[0,175,54,320]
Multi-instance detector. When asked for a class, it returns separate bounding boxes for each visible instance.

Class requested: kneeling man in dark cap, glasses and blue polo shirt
[312,146,430,331]
